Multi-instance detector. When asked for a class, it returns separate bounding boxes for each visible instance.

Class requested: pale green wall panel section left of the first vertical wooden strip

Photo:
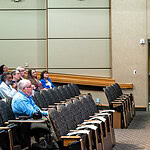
[0,0,46,69]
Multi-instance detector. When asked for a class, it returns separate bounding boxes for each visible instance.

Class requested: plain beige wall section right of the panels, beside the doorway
[112,0,148,107]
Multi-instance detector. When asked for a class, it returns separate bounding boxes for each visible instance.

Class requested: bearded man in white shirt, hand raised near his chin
[0,72,17,98]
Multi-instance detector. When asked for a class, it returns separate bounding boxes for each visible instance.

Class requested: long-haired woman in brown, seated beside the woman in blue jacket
[27,69,43,91]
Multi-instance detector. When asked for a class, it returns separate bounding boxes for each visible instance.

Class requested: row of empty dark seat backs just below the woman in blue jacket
[34,84,81,108]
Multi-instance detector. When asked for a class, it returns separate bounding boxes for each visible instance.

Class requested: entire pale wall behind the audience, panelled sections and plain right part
[0,0,150,107]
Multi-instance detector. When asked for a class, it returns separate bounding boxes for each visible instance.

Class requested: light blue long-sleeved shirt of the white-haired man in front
[11,91,48,118]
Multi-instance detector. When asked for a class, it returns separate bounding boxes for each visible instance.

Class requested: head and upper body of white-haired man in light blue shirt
[12,79,48,118]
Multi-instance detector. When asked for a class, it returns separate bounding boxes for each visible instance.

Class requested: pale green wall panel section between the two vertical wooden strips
[48,0,111,77]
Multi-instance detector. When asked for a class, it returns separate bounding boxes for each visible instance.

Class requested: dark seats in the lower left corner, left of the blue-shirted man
[0,100,30,150]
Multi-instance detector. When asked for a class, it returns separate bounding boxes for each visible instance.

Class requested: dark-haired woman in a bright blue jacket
[40,71,55,89]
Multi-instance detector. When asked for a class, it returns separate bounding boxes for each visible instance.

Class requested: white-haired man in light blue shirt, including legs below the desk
[12,79,57,149]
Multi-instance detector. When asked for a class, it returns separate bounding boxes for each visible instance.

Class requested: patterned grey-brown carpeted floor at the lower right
[113,111,150,150]
